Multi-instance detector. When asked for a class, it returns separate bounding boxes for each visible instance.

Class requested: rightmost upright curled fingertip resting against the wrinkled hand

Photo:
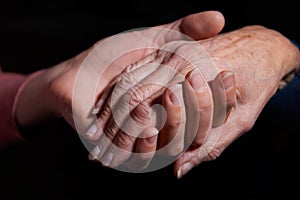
[211,70,236,127]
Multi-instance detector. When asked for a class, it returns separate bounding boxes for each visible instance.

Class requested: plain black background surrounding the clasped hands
[0,0,300,199]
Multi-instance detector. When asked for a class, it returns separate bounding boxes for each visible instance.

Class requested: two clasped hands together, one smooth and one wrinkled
[35,11,300,177]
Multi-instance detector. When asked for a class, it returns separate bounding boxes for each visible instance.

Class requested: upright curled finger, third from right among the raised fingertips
[158,84,186,156]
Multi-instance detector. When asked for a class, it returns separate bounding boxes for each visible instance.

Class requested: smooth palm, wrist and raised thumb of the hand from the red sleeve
[16,11,224,162]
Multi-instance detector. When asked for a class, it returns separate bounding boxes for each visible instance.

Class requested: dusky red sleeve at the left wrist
[0,71,26,147]
